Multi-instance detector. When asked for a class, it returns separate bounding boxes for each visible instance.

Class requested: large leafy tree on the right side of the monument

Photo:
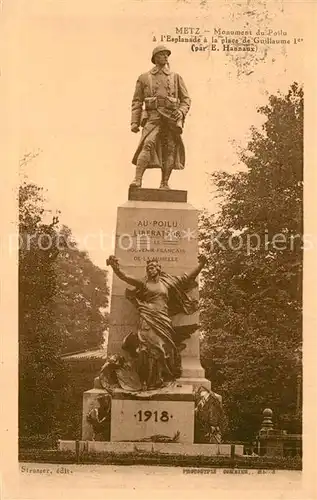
[201,83,303,439]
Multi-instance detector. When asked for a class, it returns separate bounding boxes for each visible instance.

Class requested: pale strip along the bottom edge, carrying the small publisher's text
[2,463,311,500]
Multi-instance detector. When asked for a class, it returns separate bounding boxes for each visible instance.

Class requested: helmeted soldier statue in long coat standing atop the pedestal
[131,45,191,189]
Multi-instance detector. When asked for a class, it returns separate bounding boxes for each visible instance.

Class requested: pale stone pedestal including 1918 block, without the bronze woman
[78,188,220,446]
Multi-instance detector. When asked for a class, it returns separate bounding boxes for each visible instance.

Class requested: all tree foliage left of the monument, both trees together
[19,181,109,435]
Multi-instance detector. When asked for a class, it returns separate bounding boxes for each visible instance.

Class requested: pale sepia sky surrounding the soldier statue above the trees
[11,0,307,267]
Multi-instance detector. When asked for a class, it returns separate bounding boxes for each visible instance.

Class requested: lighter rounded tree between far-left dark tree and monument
[56,226,109,353]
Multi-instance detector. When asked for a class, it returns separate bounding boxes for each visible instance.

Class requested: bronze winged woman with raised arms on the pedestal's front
[105,256,206,390]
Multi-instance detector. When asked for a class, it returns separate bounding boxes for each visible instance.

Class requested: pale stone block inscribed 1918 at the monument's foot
[110,385,195,443]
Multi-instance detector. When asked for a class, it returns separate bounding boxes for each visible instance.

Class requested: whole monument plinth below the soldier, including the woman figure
[82,188,217,444]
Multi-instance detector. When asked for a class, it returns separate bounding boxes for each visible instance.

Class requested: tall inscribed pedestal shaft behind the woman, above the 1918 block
[107,188,210,389]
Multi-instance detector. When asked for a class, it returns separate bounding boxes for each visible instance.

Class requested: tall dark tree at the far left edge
[19,182,64,435]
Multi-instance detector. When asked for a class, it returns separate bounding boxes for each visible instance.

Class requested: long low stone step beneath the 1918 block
[58,440,243,457]
